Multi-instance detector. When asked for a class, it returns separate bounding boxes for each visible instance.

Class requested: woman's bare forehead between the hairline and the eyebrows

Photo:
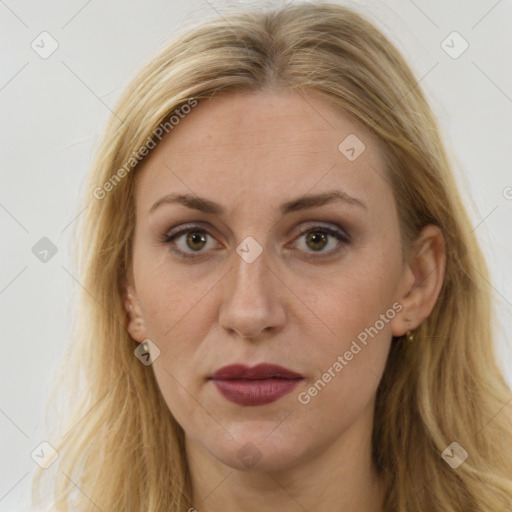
[136,91,390,215]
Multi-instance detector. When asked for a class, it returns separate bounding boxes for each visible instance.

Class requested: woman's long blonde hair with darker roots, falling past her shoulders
[33,2,512,512]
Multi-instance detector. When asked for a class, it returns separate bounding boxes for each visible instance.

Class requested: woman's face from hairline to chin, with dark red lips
[128,92,411,470]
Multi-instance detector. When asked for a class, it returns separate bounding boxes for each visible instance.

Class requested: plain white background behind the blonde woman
[0,0,512,512]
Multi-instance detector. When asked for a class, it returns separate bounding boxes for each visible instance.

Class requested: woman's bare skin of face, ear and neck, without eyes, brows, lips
[126,90,445,512]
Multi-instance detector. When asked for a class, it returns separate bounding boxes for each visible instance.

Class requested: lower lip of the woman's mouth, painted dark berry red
[213,378,302,405]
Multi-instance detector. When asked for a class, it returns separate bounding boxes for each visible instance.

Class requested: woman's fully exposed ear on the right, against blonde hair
[391,224,446,336]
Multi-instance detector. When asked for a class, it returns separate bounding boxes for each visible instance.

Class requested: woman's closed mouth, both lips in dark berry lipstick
[209,363,304,406]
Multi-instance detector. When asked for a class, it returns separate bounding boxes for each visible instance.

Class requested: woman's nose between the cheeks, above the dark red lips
[219,248,286,340]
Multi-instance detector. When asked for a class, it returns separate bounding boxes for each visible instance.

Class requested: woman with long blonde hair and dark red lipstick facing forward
[32,3,512,512]
